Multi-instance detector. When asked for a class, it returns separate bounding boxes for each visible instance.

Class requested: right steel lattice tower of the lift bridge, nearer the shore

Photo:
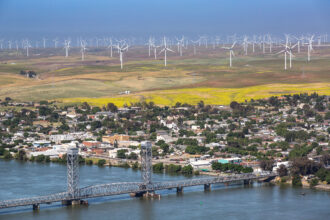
[141,141,152,186]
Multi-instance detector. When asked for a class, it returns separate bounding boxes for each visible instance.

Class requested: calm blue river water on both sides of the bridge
[0,160,330,220]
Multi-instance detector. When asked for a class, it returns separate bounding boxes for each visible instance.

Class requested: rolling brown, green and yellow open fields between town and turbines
[0,47,330,106]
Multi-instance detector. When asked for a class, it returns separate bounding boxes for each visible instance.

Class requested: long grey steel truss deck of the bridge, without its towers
[0,173,276,208]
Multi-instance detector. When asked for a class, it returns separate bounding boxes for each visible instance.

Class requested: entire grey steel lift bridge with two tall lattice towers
[0,141,276,210]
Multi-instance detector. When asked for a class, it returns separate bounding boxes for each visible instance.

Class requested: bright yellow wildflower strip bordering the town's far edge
[59,83,330,107]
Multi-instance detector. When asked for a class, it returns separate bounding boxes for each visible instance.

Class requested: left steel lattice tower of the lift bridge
[67,148,79,199]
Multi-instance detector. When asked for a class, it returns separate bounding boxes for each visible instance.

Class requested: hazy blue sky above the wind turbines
[0,0,330,36]
